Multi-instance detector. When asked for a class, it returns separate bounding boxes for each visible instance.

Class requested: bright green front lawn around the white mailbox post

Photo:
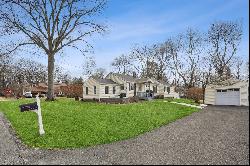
[0,99,198,148]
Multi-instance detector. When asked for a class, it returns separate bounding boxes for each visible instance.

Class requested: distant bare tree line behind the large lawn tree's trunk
[0,55,83,92]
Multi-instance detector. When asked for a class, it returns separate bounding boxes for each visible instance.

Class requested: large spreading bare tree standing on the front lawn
[0,0,106,100]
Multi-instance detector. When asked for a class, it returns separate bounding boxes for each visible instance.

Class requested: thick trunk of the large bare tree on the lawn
[46,54,55,101]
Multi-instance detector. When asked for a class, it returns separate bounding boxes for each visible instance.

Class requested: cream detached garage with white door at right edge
[205,79,249,106]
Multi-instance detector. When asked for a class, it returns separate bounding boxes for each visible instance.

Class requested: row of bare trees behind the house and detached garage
[111,21,249,88]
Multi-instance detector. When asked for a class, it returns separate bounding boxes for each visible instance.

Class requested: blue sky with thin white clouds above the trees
[19,0,249,77]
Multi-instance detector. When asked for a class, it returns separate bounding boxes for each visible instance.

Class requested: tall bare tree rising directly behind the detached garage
[208,21,242,78]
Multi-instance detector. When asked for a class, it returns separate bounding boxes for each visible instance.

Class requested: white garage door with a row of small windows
[215,89,240,105]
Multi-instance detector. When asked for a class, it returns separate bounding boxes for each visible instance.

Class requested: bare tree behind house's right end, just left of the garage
[165,28,203,88]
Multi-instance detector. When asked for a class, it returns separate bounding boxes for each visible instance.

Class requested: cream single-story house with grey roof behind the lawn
[83,73,178,99]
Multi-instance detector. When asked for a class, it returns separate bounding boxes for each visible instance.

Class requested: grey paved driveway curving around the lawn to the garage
[0,106,249,165]
